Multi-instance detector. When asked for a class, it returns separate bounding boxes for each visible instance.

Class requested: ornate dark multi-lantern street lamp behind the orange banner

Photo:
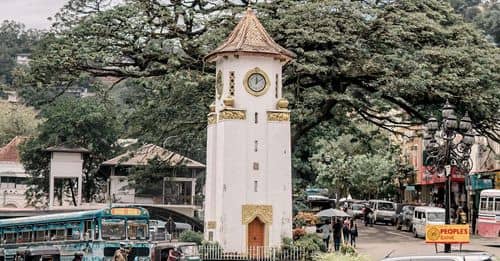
[424,101,474,253]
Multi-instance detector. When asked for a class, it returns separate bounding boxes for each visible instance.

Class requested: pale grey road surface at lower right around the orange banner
[357,219,500,260]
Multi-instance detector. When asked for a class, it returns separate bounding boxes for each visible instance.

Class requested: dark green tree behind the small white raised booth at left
[21,98,118,205]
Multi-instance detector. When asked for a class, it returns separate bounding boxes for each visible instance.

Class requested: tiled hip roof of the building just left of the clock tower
[102,144,205,168]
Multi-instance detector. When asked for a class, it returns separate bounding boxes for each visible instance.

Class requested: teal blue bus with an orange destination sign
[0,207,152,261]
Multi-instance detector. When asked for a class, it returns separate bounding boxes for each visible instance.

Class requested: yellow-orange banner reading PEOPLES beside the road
[425,224,470,244]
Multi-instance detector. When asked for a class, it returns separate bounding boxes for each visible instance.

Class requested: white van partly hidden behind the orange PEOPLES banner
[411,207,445,238]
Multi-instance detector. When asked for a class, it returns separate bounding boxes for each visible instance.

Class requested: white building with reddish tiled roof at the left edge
[0,137,28,208]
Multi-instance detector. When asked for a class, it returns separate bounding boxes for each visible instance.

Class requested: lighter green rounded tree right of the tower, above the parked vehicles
[310,124,399,199]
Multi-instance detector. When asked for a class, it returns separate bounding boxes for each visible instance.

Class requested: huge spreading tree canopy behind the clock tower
[17,0,500,183]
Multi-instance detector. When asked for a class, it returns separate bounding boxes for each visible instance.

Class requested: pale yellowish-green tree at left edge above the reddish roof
[0,102,41,146]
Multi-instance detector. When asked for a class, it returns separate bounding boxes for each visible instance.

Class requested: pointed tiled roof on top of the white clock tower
[205,8,295,62]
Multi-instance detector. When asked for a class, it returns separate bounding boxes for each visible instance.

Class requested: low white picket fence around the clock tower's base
[200,246,308,261]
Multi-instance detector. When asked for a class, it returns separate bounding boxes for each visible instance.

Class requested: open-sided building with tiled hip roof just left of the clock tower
[101,144,205,216]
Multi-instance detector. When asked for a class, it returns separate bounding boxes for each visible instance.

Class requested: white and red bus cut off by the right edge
[477,189,500,239]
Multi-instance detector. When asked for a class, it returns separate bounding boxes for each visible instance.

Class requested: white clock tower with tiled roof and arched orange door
[205,9,294,252]
